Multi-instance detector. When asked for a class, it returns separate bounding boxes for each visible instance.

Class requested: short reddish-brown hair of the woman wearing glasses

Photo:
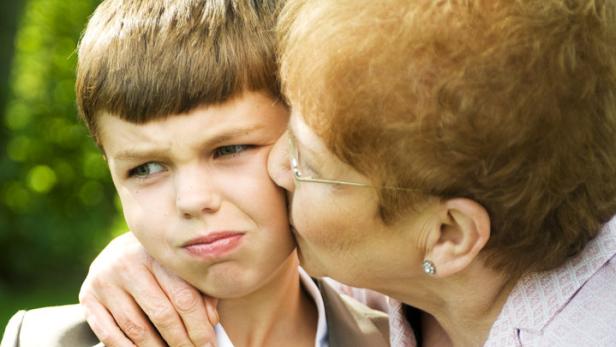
[279,0,616,275]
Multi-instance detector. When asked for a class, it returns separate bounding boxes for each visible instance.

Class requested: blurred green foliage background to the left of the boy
[0,0,126,331]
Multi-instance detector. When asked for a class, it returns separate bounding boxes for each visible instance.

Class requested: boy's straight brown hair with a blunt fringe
[76,0,281,145]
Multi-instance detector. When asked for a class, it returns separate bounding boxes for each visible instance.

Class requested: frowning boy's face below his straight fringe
[99,93,295,298]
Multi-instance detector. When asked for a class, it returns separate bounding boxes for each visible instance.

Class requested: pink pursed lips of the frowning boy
[182,231,244,258]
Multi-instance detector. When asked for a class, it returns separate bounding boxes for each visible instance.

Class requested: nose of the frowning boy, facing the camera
[176,168,222,219]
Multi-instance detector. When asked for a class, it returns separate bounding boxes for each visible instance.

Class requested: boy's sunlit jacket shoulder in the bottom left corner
[0,305,99,347]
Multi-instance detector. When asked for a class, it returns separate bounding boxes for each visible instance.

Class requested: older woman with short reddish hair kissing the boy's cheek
[79,0,616,346]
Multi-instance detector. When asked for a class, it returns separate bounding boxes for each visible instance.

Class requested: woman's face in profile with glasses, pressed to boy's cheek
[269,112,430,290]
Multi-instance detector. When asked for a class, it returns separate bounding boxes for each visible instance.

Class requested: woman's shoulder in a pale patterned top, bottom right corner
[486,219,616,346]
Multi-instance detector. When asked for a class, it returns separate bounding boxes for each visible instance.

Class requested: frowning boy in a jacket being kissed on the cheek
[2,0,388,347]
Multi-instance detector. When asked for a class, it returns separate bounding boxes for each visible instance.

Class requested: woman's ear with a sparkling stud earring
[426,198,490,277]
